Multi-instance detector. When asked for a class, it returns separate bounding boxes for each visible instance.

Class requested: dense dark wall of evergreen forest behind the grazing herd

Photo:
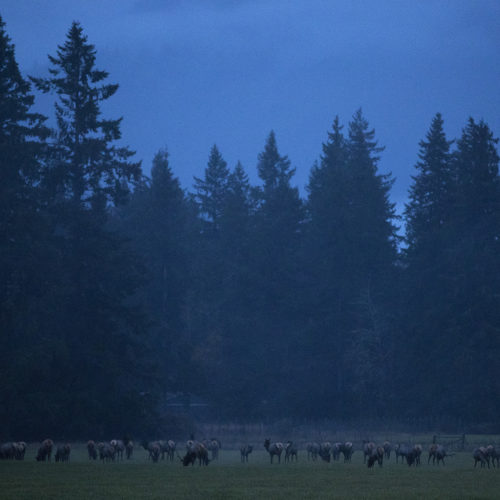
[0,19,500,440]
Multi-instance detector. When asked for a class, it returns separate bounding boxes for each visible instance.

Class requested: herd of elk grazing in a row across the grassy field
[0,438,500,468]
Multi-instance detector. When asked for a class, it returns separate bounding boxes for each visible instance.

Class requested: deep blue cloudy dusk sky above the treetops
[0,0,500,209]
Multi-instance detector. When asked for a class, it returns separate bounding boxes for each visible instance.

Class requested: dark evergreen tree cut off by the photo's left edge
[0,17,51,435]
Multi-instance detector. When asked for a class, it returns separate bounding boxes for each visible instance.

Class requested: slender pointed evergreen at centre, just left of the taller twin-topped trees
[249,132,304,414]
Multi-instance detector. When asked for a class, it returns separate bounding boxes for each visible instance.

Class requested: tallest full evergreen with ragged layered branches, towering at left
[24,22,150,435]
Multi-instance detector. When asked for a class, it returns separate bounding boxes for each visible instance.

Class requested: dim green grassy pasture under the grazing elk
[0,444,500,500]
